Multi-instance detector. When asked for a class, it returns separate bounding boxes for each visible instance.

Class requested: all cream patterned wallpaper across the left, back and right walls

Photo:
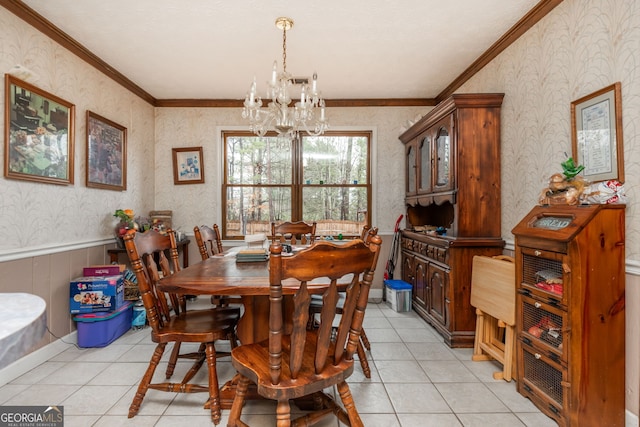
[5,0,640,260]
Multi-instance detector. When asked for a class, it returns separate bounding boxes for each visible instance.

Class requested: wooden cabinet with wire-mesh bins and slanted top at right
[513,205,625,427]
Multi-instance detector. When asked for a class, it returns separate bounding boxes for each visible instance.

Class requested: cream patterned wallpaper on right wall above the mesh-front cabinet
[459,0,640,260]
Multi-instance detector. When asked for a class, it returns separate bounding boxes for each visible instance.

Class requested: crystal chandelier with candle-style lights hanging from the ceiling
[242,17,329,137]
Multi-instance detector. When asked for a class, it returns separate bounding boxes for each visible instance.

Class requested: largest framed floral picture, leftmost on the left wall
[4,74,75,185]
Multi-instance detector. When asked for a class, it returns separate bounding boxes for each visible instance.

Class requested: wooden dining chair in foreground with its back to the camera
[228,229,381,427]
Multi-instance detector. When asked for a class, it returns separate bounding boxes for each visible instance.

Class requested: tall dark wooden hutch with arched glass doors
[400,94,504,347]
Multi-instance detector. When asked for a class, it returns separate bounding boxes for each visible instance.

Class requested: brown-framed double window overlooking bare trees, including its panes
[222,132,371,239]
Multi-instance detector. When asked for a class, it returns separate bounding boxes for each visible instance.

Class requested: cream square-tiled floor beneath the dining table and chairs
[0,299,556,427]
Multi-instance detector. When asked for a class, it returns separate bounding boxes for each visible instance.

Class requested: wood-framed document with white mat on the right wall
[571,82,624,182]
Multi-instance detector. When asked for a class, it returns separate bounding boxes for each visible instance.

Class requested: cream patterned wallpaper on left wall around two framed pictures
[0,8,154,256]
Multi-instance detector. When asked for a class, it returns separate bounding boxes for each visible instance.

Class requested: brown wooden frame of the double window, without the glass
[220,128,375,240]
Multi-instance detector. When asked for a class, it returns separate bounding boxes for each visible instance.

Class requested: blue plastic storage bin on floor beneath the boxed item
[73,301,133,347]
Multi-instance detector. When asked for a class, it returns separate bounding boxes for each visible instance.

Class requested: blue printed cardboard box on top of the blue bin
[69,274,124,314]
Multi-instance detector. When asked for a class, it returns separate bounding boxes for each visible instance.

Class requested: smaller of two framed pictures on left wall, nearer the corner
[87,110,127,191]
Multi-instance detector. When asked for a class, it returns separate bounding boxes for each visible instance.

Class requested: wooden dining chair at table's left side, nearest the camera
[124,230,238,424]
